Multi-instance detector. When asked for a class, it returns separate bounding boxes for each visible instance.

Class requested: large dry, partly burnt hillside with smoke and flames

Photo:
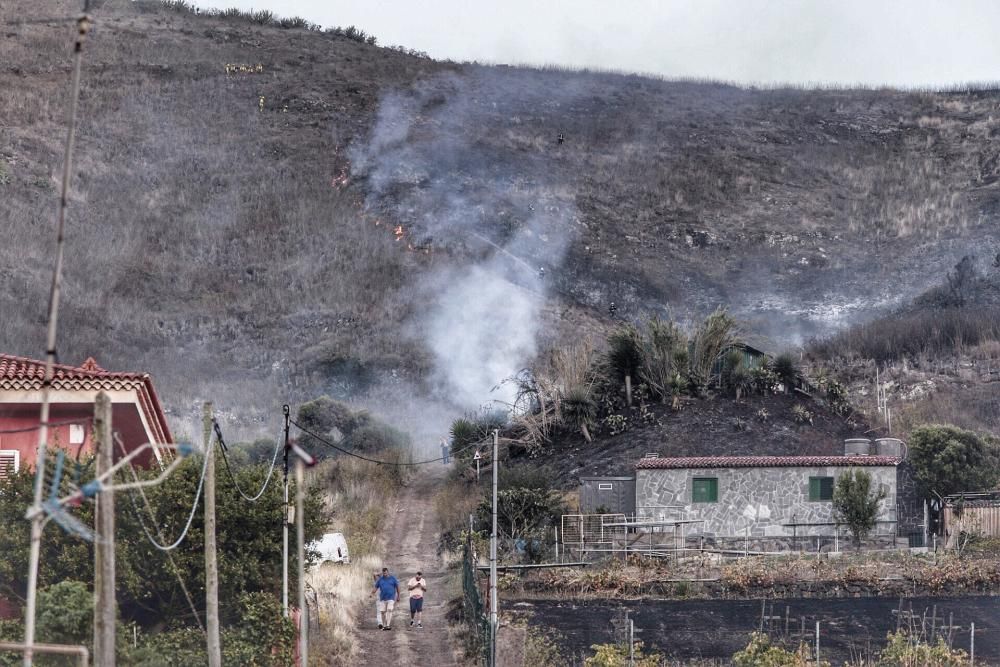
[0,0,1000,438]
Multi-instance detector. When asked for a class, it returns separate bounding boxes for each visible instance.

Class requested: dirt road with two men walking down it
[357,466,459,666]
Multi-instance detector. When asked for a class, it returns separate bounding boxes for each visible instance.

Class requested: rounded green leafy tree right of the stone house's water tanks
[908,424,998,496]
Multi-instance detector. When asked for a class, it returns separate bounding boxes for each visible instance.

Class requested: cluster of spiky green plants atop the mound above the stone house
[472,308,808,455]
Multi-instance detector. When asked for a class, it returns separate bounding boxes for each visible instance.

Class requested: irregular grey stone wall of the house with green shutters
[636,466,896,538]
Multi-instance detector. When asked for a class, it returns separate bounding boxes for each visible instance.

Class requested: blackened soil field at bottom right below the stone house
[502,597,1000,665]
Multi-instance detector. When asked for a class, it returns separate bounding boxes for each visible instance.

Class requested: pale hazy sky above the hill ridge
[200,0,1000,86]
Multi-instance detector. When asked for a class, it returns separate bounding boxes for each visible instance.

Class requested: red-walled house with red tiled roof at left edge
[0,354,173,476]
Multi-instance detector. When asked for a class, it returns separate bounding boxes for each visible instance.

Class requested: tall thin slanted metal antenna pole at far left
[24,8,90,667]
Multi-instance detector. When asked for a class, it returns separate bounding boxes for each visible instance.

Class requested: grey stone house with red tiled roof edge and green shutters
[635,454,901,550]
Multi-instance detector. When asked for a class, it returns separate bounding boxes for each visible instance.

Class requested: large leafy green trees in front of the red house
[0,457,326,626]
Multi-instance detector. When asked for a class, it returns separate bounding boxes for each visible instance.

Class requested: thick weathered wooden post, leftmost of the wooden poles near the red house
[94,391,116,667]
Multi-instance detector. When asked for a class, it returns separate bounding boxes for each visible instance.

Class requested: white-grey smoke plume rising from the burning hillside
[351,69,577,409]
